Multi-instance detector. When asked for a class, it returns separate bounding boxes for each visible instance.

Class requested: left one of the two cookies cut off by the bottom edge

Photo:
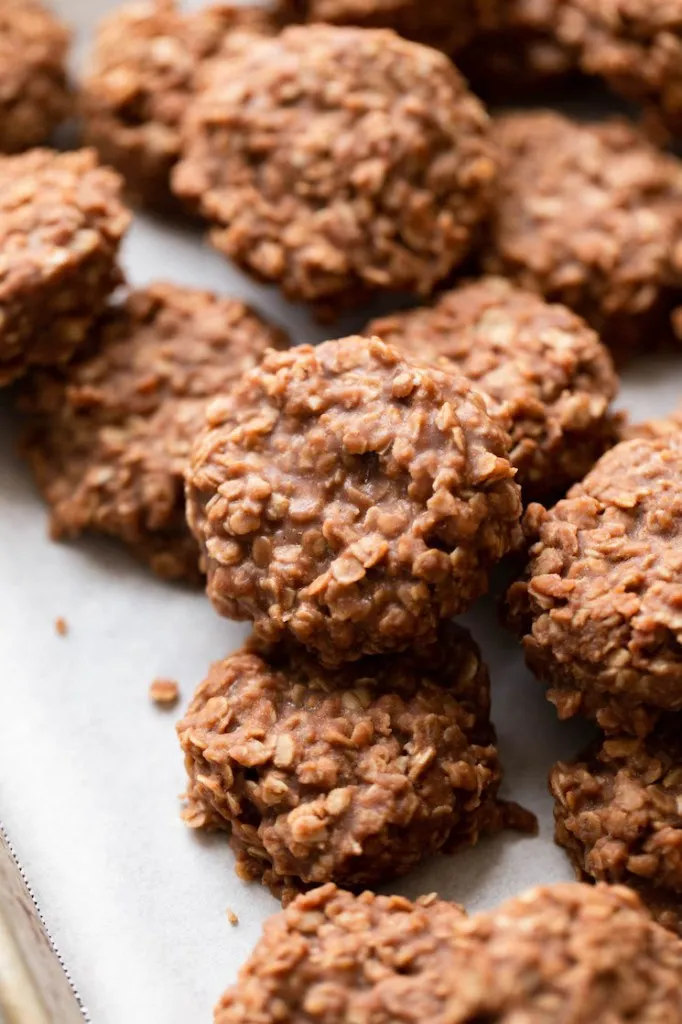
[215,885,464,1024]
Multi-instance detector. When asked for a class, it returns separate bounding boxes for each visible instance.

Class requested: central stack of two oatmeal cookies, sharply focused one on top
[178,337,531,898]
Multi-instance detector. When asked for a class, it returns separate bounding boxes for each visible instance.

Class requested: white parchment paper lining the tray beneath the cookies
[0,0,682,1024]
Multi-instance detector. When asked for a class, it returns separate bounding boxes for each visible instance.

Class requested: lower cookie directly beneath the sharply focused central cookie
[178,625,535,897]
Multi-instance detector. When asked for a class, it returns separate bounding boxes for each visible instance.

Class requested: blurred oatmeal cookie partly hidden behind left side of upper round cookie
[82,0,271,209]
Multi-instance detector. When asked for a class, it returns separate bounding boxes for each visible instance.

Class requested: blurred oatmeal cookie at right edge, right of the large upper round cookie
[483,112,682,353]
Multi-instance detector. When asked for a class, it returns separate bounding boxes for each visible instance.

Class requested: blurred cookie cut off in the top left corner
[0,0,72,153]
